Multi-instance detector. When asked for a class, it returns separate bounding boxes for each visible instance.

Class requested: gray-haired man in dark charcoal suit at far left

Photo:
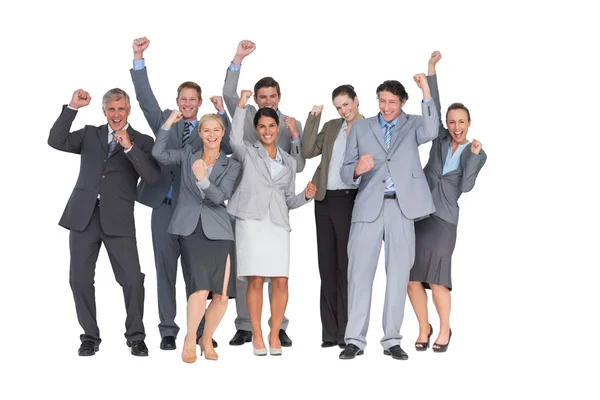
[48,89,160,356]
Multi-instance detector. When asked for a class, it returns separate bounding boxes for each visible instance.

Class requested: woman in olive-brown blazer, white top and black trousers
[302,85,362,348]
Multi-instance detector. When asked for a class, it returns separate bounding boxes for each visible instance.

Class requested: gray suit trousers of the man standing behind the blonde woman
[152,203,190,338]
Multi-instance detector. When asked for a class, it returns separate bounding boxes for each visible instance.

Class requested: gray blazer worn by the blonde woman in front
[152,128,241,240]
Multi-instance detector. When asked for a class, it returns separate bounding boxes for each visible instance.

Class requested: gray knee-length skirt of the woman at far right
[410,215,456,290]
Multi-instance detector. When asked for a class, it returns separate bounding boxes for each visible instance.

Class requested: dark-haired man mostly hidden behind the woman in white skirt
[223,40,306,347]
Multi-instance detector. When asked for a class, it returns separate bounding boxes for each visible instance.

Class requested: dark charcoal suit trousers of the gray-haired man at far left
[69,206,146,344]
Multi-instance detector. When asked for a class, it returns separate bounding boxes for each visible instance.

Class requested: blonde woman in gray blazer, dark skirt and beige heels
[152,110,241,363]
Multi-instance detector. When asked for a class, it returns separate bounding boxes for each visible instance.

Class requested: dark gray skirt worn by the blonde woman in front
[180,217,236,298]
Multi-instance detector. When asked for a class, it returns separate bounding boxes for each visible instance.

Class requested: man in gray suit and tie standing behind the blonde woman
[131,37,232,350]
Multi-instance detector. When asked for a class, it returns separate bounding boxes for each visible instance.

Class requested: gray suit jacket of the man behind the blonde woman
[130,68,231,208]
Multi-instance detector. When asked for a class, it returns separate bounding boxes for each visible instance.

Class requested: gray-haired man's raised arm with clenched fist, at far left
[48,89,92,154]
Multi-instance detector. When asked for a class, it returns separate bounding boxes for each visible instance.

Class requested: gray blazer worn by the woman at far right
[424,75,487,225]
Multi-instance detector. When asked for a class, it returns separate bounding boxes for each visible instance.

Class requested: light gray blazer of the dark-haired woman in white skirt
[227,108,310,232]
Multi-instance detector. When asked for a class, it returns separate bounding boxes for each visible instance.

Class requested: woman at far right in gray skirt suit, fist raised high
[408,51,487,353]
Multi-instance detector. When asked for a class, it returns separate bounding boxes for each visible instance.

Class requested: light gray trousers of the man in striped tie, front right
[345,199,415,349]
